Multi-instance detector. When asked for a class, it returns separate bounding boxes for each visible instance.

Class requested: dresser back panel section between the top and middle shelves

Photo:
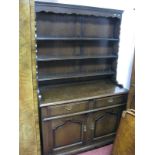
[37,40,118,60]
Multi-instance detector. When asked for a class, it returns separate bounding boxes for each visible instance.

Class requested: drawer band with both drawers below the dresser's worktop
[41,95,127,118]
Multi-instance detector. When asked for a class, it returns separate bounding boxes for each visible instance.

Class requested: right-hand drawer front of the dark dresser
[94,94,127,108]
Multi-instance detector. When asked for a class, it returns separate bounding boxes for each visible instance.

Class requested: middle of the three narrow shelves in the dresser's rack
[37,55,118,62]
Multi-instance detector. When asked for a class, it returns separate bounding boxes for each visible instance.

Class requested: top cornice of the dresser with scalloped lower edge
[35,2,123,18]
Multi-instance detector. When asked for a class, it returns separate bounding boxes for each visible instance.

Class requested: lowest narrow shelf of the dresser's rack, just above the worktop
[38,71,115,82]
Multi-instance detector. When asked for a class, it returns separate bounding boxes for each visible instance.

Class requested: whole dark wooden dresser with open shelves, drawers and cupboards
[35,2,128,155]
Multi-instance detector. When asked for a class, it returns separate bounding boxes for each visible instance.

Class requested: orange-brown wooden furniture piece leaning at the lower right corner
[112,109,135,155]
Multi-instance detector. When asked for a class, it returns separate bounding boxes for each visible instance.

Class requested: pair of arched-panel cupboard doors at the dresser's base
[42,105,125,155]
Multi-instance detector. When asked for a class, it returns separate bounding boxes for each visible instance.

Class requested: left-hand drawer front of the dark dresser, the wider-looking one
[42,101,89,117]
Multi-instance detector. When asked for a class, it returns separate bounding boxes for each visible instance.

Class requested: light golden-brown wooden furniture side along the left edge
[19,0,40,155]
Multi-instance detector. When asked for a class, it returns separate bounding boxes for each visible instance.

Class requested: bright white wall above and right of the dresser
[36,0,135,89]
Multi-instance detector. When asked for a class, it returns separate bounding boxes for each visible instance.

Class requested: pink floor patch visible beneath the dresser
[78,144,112,155]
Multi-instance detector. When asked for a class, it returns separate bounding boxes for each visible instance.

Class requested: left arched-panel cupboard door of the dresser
[42,116,86,155]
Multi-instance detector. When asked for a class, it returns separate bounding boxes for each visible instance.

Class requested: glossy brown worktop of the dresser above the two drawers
[40,80,128,106]
